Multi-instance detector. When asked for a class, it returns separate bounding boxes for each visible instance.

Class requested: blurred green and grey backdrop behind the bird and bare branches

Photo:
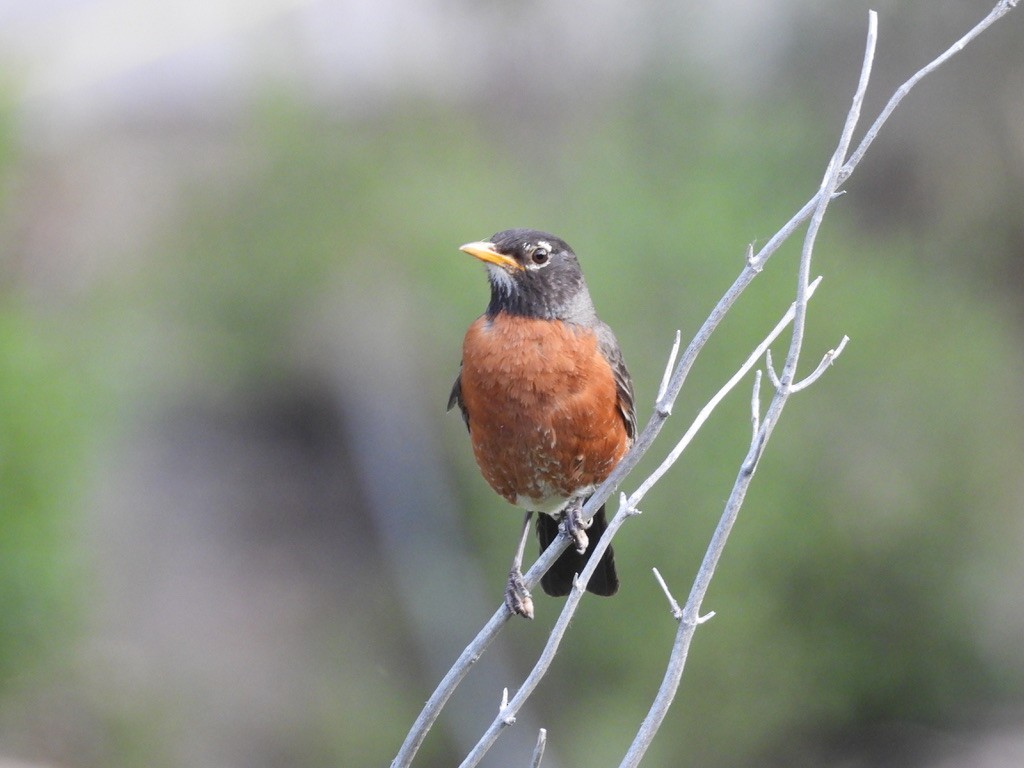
[0,0,1024,768]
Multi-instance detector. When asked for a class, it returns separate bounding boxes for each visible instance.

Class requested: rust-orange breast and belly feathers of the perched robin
[462,312,630,512]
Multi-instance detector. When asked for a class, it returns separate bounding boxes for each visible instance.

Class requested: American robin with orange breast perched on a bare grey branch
[449,229,636,617]
